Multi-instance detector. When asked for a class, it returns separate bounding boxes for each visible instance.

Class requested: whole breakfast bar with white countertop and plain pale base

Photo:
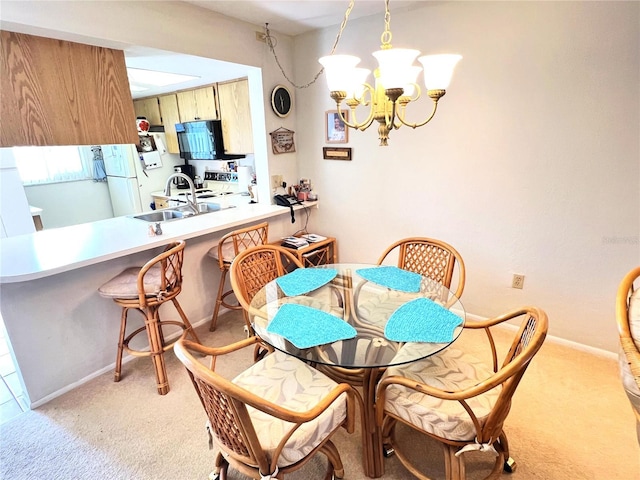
[0,202,316,407]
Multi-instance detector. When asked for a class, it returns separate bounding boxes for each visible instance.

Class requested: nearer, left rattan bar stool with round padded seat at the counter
[98,240,200,395]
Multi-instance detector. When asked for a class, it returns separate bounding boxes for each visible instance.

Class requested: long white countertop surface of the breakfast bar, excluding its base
[0,202,317,283]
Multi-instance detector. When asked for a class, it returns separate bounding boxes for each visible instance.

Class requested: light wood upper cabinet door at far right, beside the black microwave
[218,78,253,153]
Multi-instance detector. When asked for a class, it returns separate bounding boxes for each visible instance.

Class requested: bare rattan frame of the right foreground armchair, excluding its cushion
[376,307,548,480]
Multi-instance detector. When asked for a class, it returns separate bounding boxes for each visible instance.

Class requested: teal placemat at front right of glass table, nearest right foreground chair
[384,298,462,343]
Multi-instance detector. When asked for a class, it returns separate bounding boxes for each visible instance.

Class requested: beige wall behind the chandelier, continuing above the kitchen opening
[2,1,640,352]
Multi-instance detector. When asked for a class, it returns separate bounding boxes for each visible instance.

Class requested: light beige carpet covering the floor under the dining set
[0,312,640,480]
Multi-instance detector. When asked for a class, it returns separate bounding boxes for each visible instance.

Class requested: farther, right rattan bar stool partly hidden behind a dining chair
[208,222,269,333]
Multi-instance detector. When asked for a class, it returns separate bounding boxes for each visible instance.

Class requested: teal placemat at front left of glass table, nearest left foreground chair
[267,303,356,348]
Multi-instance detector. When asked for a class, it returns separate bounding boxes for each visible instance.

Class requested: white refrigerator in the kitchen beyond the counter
[101,135,173,217]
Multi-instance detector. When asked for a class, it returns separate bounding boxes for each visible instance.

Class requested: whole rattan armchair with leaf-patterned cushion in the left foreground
[175,337,355,480]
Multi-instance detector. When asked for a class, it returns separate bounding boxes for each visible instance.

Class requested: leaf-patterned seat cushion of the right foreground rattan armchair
[383,348,502,441]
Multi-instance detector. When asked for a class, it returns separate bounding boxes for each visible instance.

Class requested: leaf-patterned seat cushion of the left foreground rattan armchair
[233,351,346,467]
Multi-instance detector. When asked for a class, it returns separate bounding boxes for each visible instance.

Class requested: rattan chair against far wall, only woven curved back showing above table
[377,237,465,298]
